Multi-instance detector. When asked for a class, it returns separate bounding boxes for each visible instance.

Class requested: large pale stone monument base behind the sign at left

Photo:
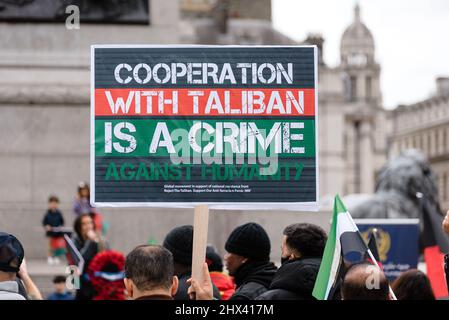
[0,0,182,259]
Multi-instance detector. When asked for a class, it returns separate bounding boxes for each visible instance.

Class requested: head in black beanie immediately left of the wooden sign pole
[162,225,193,274]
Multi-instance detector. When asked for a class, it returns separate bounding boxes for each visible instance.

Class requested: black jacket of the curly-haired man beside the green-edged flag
[257,258,321,300]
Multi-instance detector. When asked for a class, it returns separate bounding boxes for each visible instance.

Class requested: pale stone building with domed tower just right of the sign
[316,6,391,205]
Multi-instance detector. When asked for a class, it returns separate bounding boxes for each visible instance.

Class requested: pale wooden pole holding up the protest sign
[192,205,209,283]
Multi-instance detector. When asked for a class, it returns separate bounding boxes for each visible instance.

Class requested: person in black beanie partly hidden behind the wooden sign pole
[163,225,221,300]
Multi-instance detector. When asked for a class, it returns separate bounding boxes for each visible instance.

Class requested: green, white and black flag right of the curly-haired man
[312,195,384,300]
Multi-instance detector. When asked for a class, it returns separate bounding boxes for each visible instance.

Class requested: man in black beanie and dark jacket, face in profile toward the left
[224,222,276,300]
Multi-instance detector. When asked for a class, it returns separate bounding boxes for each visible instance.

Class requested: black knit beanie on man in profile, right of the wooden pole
[225,222,271,261]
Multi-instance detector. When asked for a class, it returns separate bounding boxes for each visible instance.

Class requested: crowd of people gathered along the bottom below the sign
[0,185,449,301]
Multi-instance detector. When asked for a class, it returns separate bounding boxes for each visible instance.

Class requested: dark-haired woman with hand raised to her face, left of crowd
[72,214,106,300]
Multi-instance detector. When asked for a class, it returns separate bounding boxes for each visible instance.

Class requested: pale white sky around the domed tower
[272,0,449,109]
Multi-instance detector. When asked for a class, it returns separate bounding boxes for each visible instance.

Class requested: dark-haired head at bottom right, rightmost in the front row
[391,269,435,300]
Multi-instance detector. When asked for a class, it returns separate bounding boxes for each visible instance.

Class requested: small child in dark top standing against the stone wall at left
[42,196,65,265]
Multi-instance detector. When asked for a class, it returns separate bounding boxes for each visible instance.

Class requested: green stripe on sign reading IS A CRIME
[95,118,315,158]
